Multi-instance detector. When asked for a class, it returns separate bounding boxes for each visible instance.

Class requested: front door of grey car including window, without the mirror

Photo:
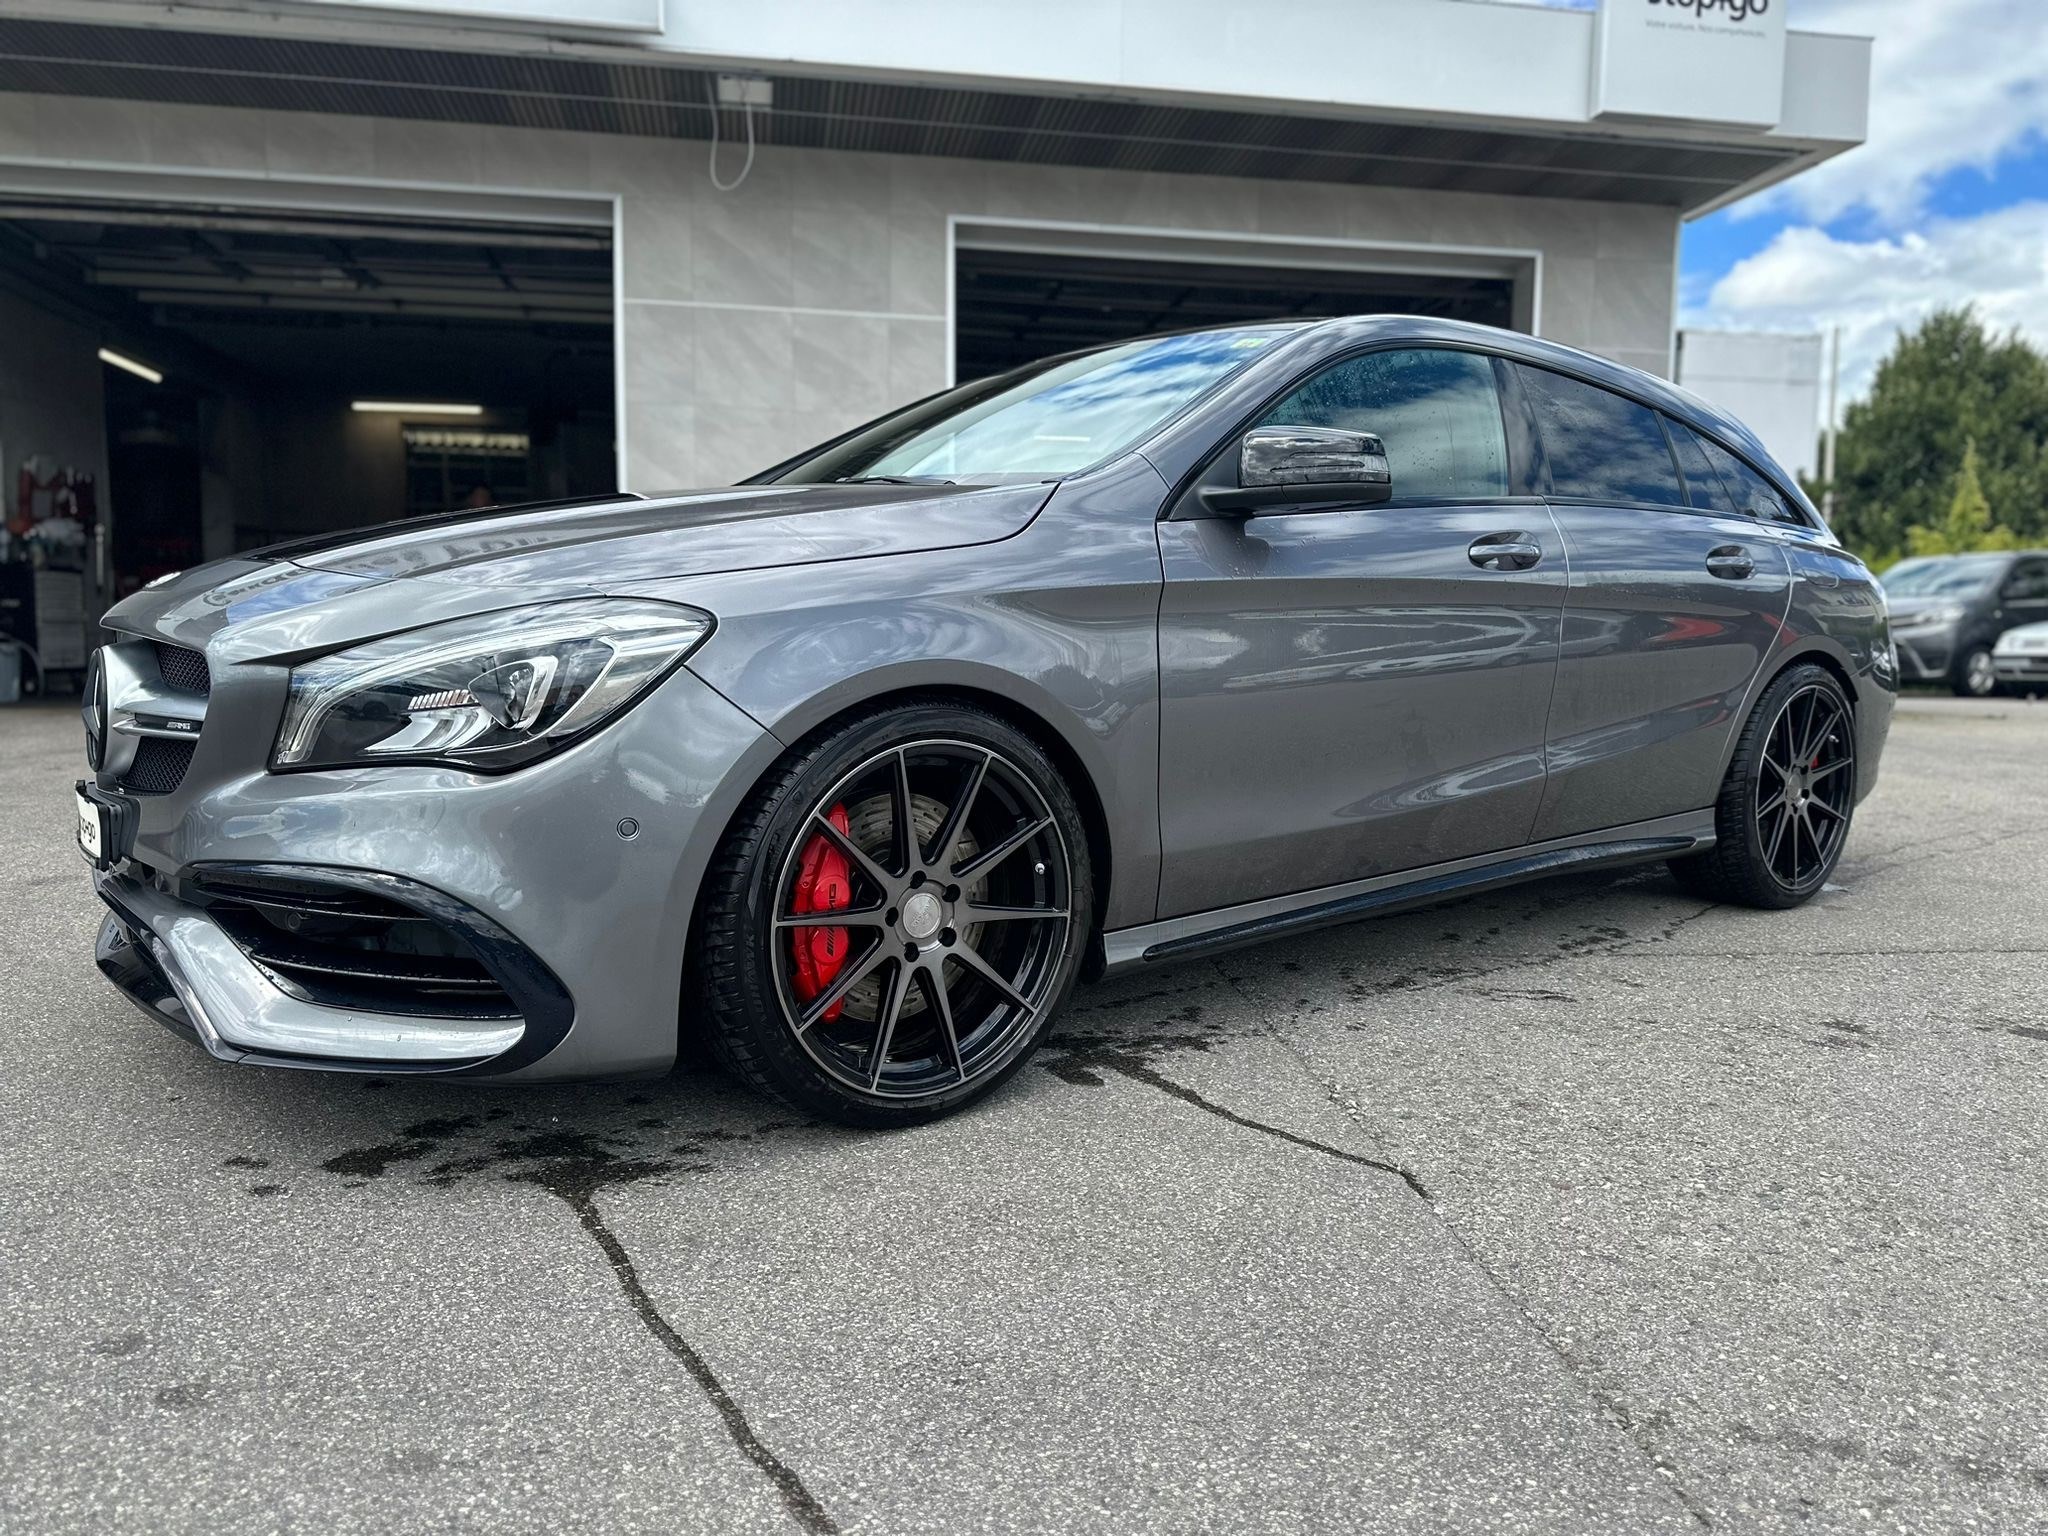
[1159,348,1565,918]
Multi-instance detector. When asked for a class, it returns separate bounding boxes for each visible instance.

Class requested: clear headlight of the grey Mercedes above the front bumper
[272,598,711,772]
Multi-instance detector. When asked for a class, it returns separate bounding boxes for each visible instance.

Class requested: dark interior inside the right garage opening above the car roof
[952,246,1518,381]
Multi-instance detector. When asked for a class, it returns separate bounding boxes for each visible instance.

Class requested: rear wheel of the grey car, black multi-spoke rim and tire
[1671,664,1855,907]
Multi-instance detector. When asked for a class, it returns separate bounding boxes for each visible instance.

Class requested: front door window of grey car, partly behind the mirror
[1260,350,1507,502]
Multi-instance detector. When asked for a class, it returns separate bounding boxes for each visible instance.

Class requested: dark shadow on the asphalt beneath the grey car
[180,868,1704,1204]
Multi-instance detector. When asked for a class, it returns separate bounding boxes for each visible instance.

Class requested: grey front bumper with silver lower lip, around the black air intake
[96,666,782,1081]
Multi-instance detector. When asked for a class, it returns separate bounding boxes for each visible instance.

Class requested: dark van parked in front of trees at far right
[1884,549,2048,698]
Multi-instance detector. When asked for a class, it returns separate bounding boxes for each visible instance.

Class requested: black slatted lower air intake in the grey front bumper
[199,874,520,1020]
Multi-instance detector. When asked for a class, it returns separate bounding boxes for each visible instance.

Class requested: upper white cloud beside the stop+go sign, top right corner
[1739,0,2048,227]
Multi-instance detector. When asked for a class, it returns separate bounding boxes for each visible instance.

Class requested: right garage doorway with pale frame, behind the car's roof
[952,237,1534,381]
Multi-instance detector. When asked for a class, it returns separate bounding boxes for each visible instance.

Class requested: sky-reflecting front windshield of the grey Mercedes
[774,326,1292,485]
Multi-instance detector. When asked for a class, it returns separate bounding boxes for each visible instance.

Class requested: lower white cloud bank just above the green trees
[1683,203,2048,409]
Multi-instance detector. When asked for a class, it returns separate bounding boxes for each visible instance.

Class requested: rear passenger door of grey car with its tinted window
[1513,362,1792,842]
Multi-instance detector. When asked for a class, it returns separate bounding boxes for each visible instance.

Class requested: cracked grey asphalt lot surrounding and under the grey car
[0,700,2048,1536]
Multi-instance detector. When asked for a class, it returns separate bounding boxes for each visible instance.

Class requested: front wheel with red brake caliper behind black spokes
[688,700,1094,1126]
